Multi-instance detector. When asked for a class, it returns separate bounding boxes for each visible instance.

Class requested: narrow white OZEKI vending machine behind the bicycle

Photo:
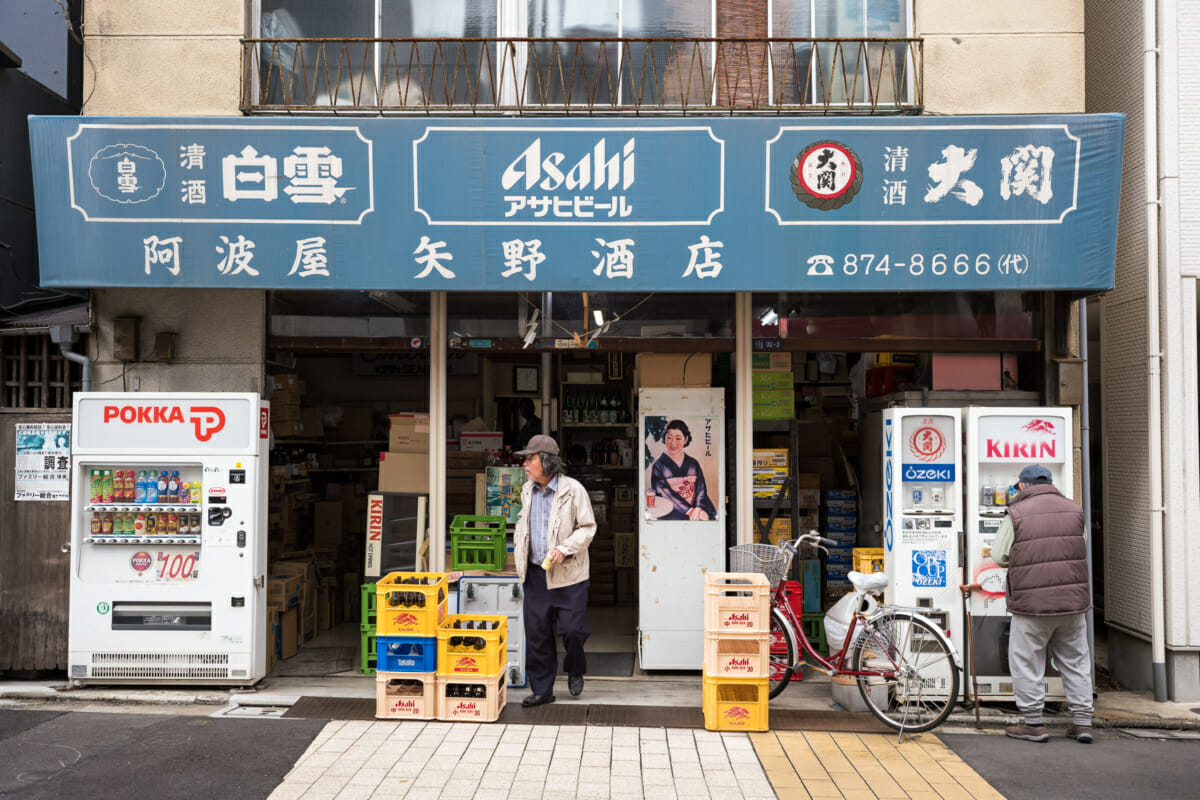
[882,408,962,652]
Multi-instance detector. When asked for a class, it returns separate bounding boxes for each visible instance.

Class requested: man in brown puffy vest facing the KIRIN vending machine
[991,464,1092,745]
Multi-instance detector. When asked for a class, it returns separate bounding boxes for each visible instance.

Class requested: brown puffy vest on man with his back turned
[1008,483,1091,616]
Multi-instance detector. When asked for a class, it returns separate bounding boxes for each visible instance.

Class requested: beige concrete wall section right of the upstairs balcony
[913,0,1084,114]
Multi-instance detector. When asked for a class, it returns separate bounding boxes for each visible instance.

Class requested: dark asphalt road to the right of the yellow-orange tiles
[937,728,1200,800]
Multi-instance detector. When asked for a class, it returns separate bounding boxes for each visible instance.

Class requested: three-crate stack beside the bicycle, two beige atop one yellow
[702,572,770,730]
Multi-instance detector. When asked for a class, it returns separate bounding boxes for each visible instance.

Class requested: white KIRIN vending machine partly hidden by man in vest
[965,405,1075,700]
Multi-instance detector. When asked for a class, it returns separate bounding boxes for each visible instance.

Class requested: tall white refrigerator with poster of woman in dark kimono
[637,387,727,669]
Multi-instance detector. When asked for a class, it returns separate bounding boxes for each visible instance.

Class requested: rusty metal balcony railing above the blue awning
[241,38,924,114]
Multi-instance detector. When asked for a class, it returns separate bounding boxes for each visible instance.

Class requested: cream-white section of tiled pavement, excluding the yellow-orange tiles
[271,722,775,800]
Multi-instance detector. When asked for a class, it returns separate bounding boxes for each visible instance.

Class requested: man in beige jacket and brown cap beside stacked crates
[512,434,596,708]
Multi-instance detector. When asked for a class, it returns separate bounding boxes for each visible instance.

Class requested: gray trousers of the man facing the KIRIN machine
[1008,613,1092,726]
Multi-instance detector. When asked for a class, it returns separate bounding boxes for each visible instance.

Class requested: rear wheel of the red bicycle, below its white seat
[851,612,959,733]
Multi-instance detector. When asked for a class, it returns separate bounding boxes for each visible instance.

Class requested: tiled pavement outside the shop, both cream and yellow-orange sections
[271,722,1003,800]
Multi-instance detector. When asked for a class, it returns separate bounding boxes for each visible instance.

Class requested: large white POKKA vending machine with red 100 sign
[68,392,269,685]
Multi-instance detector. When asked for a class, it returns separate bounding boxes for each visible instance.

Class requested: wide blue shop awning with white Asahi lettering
[30,114,1124,294]
